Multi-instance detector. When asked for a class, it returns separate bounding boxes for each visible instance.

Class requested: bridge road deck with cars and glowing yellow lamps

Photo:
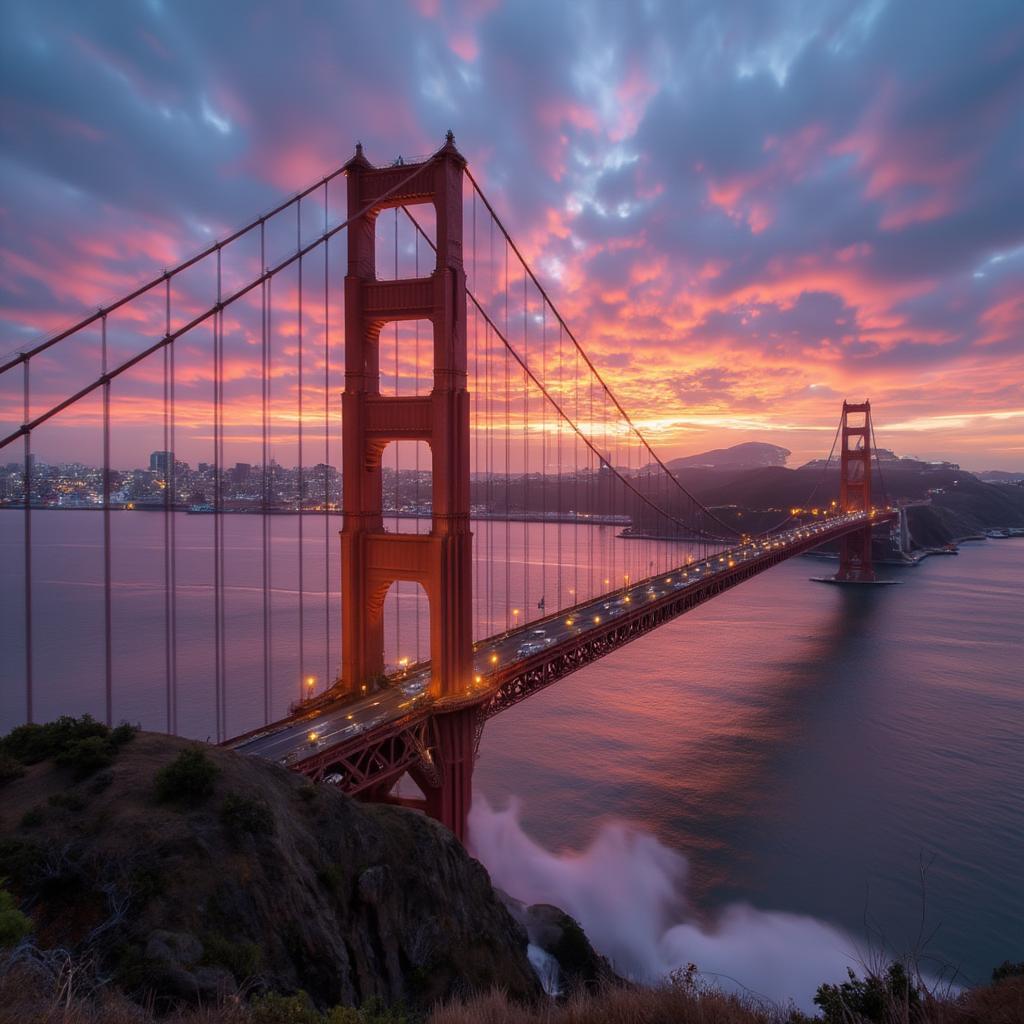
[225,510,896,793]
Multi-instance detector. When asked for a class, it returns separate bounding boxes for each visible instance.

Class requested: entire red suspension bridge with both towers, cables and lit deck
[0,132,896,838]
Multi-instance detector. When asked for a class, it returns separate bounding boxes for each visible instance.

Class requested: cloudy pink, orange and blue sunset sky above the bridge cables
[0,0,1024,470]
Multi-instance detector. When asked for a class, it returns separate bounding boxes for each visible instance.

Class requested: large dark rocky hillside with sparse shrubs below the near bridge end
[0,733,541,1008]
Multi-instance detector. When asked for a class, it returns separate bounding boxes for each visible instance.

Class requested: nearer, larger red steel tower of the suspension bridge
[341,132,475,838]
